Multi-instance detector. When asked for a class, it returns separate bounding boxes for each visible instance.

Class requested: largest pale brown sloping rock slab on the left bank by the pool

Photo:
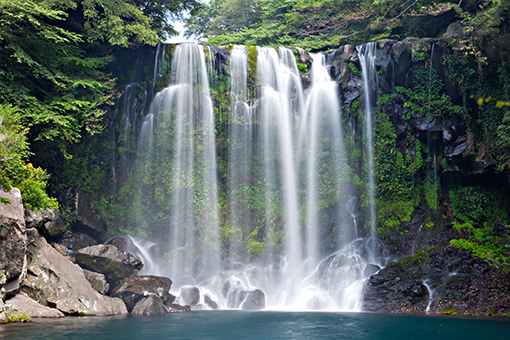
[21,229,127,315]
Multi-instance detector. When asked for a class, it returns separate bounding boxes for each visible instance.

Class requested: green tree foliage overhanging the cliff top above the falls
[187,0,508,51]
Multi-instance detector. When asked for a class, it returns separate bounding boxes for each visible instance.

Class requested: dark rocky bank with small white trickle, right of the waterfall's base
[363,226,510,315]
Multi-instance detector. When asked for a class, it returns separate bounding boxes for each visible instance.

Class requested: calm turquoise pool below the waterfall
[0,311,510,340]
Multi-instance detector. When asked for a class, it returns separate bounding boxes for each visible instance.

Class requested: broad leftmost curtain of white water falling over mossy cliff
[135,44,220,286]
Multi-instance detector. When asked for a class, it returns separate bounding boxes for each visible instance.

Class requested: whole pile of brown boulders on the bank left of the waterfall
[0,188,194,323]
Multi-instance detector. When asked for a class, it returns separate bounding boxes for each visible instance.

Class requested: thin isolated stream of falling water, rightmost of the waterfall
[357,42,377,262]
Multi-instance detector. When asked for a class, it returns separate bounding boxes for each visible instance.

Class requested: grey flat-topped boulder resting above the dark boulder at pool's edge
[76,244,143,287]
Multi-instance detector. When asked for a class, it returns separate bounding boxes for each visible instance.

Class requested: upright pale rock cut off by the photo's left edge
[0,188,27,291]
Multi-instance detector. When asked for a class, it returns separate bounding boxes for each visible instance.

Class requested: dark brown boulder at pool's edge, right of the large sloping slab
[111,275,171,311]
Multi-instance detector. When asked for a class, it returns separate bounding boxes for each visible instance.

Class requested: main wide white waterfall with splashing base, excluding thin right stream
[125,44,375,311]
